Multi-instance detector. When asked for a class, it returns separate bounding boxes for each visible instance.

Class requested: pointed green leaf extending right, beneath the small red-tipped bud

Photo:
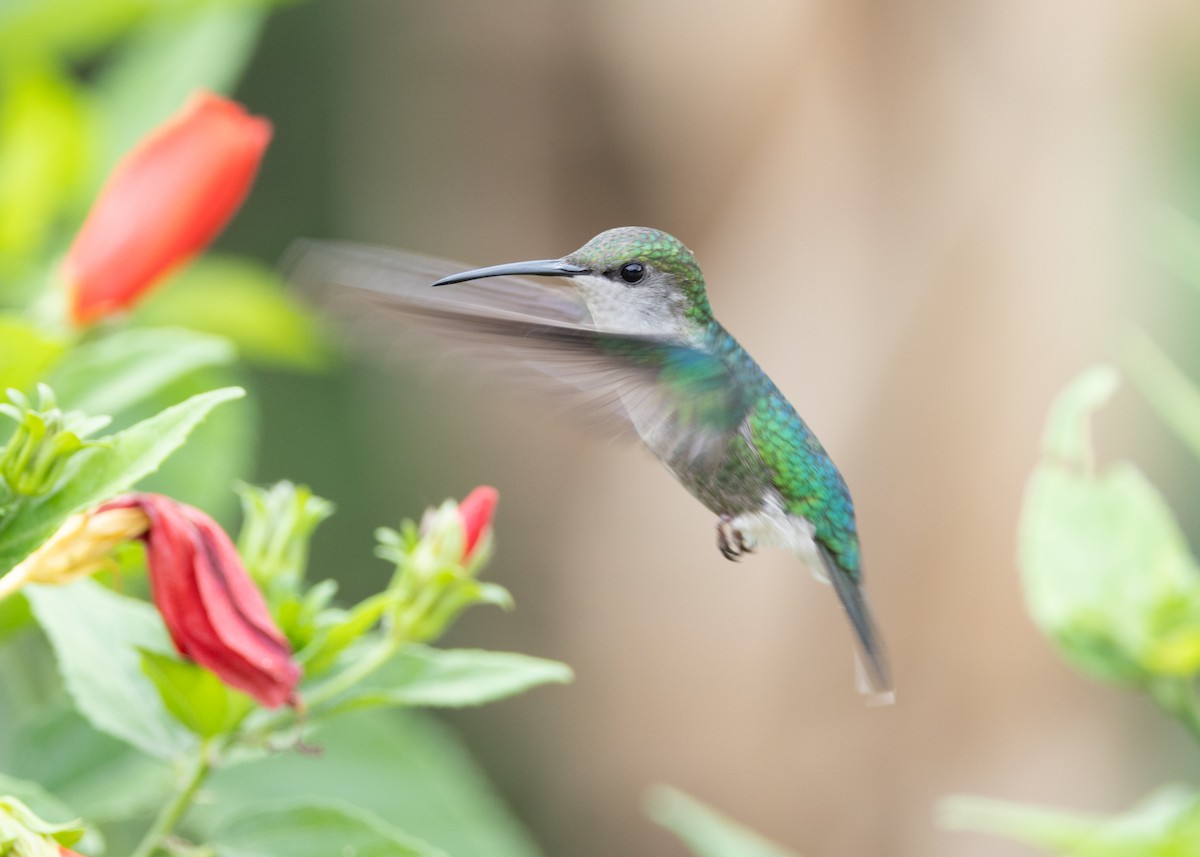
[321,645,574,709]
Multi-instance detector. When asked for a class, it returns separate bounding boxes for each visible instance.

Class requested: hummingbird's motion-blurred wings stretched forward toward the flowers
[284,242,751,457]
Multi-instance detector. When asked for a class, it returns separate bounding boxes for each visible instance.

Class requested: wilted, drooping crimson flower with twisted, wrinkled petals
[101,495,300,708]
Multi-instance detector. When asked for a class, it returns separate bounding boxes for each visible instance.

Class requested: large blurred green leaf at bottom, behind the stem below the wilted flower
[200,711,539,857]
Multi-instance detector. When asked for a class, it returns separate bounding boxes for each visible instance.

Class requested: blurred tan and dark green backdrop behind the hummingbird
[235,0,1200,857]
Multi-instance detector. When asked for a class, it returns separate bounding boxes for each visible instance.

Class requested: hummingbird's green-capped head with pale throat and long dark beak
[433,226,713,338]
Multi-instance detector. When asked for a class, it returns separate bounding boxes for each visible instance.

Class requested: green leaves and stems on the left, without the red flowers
[0,0,571,857]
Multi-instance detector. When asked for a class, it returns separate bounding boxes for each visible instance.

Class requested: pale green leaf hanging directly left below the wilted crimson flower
[25,580,197,760]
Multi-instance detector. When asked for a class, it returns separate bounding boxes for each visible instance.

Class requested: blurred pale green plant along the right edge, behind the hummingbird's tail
[940,211,1200,857]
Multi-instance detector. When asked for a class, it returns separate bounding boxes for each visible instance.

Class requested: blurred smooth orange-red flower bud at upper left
[64,92,271,324]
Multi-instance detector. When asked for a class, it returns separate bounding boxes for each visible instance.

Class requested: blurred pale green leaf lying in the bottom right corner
[940,787,1200,857]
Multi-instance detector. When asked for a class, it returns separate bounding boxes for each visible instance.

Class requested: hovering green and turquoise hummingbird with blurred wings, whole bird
[288,227,890,699]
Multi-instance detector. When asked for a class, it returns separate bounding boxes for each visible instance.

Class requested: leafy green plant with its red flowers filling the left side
[0,0,571,857]
